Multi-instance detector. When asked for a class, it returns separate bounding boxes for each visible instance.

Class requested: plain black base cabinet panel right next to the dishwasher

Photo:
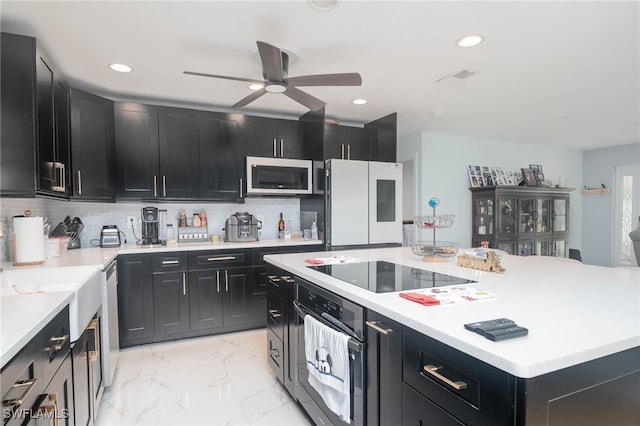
[118,254,155,346]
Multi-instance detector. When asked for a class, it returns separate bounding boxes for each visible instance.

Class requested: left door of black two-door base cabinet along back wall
[189,269,223,330]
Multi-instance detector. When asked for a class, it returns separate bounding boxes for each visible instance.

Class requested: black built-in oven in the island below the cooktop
[293,277,367,426]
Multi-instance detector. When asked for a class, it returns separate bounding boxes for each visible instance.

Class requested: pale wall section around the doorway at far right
[582,143,640,266]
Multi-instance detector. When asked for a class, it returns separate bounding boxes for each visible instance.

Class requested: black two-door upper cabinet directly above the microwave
[243,116,304,158]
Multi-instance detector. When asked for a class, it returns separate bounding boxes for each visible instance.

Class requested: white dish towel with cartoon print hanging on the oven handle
[304,315,351,423]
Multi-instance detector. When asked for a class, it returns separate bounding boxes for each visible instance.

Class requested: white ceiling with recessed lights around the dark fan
[0,0,640,149]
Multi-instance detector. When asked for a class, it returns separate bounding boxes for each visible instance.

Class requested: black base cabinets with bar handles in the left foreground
[0,307,74,426]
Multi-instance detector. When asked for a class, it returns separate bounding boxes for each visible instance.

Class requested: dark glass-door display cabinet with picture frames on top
[471,187,570,257]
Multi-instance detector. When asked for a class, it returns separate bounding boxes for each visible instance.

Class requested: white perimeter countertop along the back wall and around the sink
[0,239,321,366]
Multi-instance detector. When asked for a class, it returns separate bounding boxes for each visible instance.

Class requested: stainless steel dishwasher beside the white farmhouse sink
[101,260,120,386]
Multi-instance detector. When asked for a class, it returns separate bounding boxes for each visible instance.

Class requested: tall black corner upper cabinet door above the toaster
[70,88,116,201]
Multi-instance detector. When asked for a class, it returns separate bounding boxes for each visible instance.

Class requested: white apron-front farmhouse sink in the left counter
[0,266,103,342]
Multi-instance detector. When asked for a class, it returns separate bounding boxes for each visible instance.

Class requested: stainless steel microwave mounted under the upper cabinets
[247,157,313,195]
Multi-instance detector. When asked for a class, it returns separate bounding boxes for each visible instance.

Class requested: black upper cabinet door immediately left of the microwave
[198,111,244,200]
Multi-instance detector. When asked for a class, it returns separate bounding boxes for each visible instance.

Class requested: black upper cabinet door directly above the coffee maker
[114,103,159,199]
